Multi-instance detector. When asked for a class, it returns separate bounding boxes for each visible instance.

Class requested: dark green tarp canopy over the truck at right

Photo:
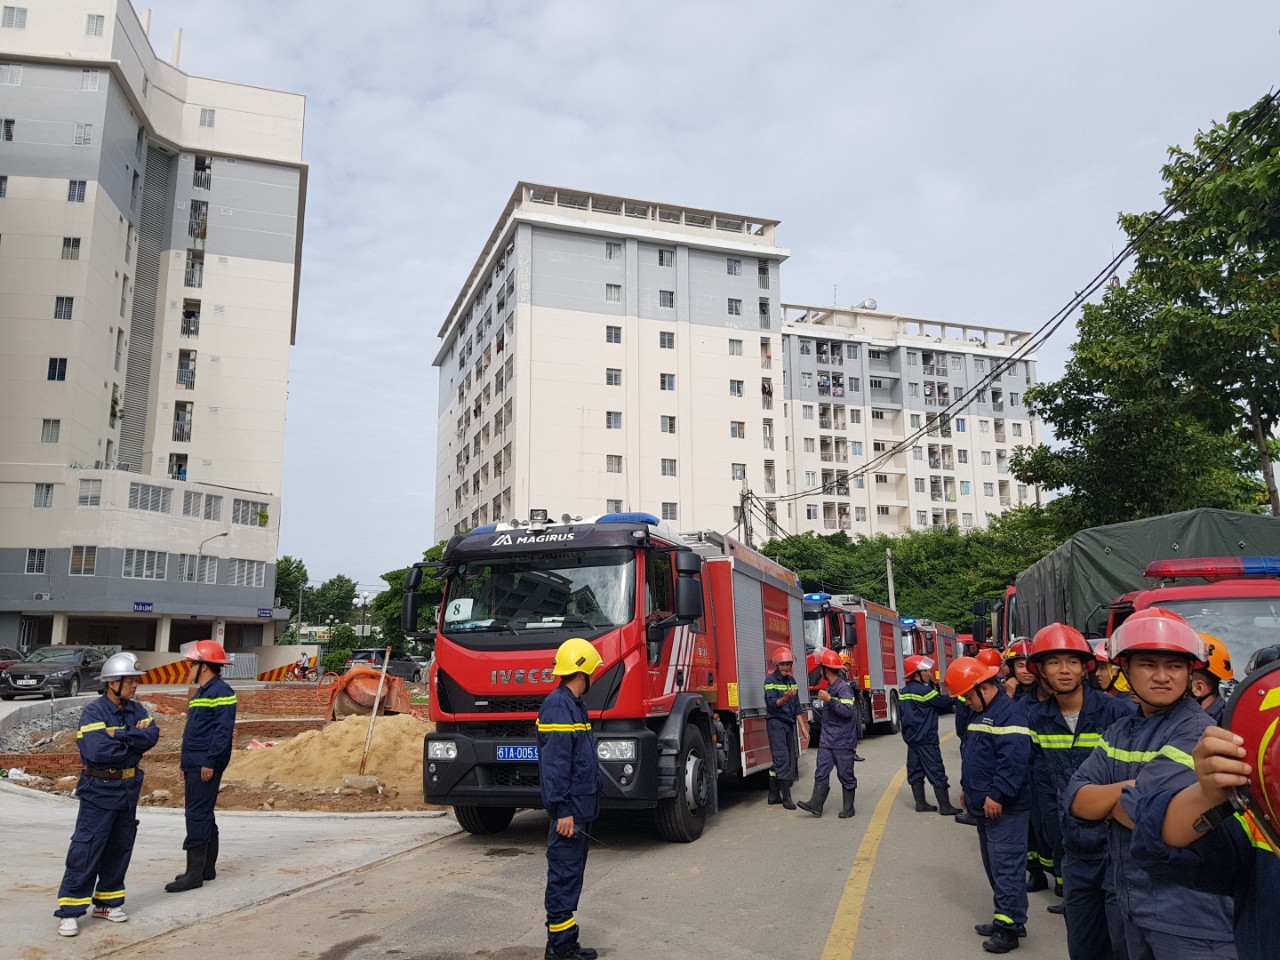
[1014,508,1280,636]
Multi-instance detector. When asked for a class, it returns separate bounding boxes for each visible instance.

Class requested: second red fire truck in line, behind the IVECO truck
[804,593,905,742]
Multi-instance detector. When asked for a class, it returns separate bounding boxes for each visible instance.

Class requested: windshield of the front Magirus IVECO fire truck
[440,549,636,635]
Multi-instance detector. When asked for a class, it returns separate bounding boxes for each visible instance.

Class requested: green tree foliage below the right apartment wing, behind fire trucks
[763,506,1061,632]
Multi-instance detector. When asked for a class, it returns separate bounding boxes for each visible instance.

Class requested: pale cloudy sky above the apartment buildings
[137,0,1280,591]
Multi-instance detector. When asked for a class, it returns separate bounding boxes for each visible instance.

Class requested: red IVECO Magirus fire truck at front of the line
[403,511,809,842]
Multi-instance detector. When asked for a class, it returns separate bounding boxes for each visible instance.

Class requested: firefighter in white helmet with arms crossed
[54,653,160,937]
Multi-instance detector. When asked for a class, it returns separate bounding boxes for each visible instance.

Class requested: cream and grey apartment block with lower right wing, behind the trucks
[435,183,1037,539]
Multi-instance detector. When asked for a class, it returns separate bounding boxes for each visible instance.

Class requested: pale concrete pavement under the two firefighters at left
[0,782,458,960]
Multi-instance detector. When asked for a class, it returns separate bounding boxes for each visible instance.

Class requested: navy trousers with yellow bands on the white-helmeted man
[54,800,138,916]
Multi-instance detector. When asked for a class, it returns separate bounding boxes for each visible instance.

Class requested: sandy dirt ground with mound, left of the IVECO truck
[7,713,440,813]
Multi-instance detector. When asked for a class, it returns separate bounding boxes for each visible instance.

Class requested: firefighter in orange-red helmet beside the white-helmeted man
[164,640,236,893]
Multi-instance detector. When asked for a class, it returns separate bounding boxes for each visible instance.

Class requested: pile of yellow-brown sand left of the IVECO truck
[224,714,431,797]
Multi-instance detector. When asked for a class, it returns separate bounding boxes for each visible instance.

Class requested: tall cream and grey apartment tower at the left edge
[0,0,307,662]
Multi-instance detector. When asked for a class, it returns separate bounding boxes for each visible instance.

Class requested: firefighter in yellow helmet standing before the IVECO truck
[538,637,600,960]
